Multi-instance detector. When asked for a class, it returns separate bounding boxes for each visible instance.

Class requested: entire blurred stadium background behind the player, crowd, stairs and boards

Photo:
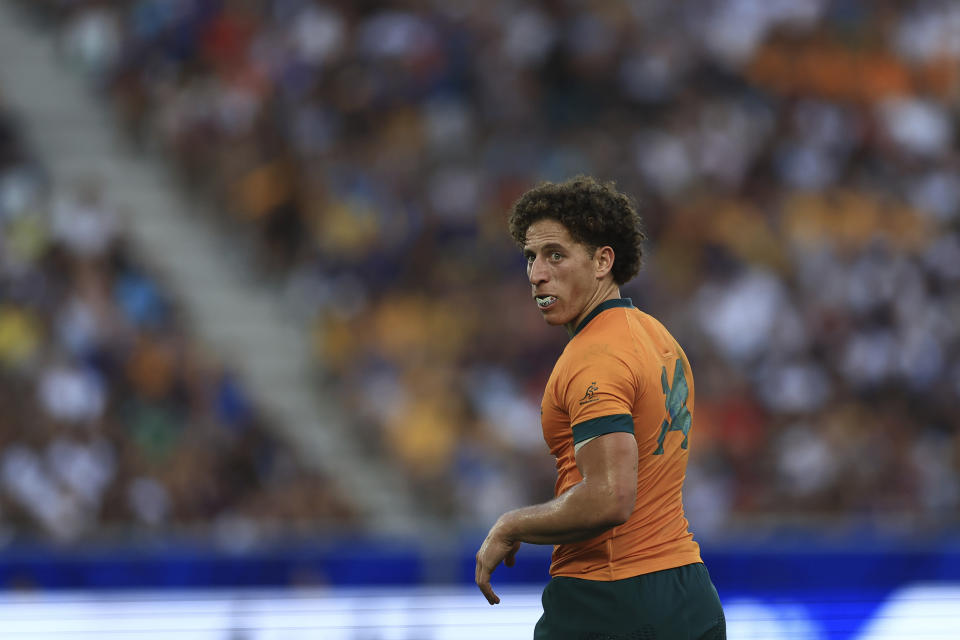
[0,0,960,640]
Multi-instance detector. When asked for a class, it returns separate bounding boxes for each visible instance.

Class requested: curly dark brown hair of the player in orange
[509,175,647,285]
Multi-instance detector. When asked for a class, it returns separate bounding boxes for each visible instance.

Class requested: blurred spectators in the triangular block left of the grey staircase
[0,100,351,543]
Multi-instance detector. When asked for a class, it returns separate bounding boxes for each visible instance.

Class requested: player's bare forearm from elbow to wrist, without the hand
[496,481,623,544]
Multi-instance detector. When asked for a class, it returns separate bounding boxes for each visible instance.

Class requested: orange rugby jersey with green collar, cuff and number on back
[541,298,701,580]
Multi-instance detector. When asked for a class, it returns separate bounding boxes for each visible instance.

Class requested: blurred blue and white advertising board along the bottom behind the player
[0,539,960,640]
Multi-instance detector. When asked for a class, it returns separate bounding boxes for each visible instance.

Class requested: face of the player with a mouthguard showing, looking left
[523,219,609,329]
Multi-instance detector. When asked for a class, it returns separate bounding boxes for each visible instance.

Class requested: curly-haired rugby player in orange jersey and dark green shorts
[476,176,726,640]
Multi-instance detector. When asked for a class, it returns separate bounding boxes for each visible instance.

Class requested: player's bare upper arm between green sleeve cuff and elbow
[576,431,639,522]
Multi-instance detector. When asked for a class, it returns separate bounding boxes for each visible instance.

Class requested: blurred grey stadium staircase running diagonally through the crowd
[0,0,426,534]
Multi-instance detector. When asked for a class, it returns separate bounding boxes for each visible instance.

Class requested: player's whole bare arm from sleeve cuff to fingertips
[475,432,638,604]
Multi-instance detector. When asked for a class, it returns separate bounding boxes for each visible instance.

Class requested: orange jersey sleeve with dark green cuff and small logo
[557,345,639,444]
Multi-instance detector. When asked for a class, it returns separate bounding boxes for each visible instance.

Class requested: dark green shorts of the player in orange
[533,562,727,640]
